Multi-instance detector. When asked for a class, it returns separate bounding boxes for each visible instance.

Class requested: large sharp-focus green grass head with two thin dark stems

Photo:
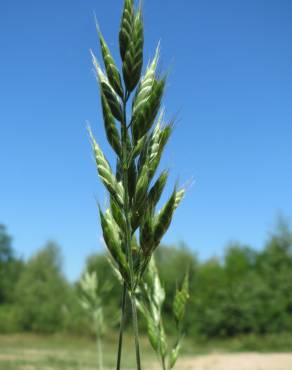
[89,0,185,370]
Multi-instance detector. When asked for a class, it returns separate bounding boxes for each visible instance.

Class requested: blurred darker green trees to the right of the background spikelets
[192,220,292,338]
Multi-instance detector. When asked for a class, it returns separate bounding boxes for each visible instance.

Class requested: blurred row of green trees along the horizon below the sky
[0,222,292,339]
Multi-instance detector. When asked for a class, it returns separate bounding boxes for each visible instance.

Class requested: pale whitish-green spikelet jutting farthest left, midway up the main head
[88,128,124,206]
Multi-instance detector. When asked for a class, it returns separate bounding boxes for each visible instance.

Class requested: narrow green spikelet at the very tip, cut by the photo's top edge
[119,0,134,60]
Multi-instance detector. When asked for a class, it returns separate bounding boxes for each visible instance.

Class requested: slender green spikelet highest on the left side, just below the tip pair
[98,29,124,98]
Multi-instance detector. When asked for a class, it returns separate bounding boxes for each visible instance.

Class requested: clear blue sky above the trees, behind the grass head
[0,0,292,279]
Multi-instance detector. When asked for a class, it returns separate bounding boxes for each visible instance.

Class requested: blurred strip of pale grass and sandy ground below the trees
[0,335,292,370]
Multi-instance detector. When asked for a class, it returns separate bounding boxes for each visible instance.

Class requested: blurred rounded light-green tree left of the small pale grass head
[16,243,68,333]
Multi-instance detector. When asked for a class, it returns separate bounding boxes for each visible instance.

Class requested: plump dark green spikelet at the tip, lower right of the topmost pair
[123,9,144,92]
